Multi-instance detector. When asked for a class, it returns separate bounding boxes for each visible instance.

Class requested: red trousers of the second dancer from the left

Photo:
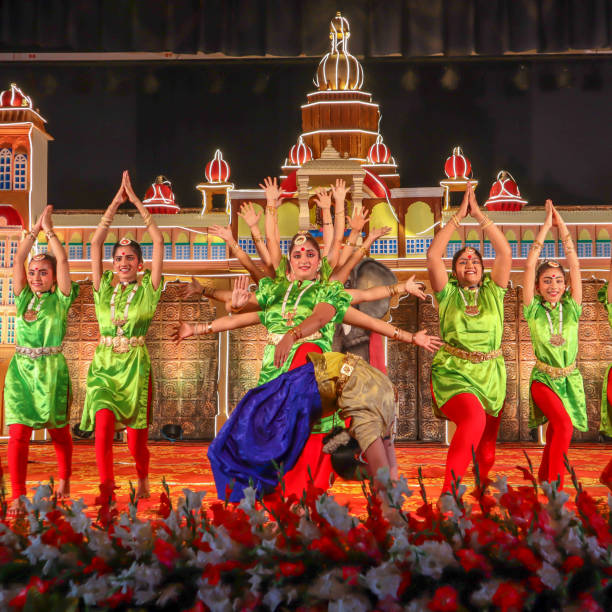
[95,378,153,488]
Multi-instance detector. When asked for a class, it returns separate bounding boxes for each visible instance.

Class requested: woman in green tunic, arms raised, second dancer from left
[81,170,164,502]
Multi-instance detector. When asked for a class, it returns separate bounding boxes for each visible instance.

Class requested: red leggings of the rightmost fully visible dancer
[530,381,574,487]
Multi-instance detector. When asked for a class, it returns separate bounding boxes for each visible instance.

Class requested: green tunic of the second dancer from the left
[81,270,163,431]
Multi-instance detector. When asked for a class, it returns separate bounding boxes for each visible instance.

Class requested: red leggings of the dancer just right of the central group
[441,393,500,493]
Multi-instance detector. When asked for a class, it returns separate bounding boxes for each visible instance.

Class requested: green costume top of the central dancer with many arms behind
[255,257,351,385]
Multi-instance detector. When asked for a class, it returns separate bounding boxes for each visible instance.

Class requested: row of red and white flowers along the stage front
[0,466,612,612]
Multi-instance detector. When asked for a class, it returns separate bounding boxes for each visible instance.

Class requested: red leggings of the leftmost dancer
[8,423,72,499]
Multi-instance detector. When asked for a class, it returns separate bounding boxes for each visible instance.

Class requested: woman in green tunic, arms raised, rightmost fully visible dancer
[523,200,587,488]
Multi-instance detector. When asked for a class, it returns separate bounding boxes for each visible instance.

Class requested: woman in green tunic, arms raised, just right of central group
[427,183,512,493]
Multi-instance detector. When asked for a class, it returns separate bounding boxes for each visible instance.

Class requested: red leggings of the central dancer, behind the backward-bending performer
[284,342,333,497]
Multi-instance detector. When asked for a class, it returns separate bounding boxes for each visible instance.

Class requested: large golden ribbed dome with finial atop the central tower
[314,12,363,91]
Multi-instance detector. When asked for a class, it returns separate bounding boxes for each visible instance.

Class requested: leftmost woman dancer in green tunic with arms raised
[4,206,79,514]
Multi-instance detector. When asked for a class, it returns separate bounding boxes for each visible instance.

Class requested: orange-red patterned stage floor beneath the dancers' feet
[0,441,612,518]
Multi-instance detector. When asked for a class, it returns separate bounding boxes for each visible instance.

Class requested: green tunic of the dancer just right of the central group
[431,275,506,418]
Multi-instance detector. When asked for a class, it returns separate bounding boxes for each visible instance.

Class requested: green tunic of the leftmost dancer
[4,283,79,429]
